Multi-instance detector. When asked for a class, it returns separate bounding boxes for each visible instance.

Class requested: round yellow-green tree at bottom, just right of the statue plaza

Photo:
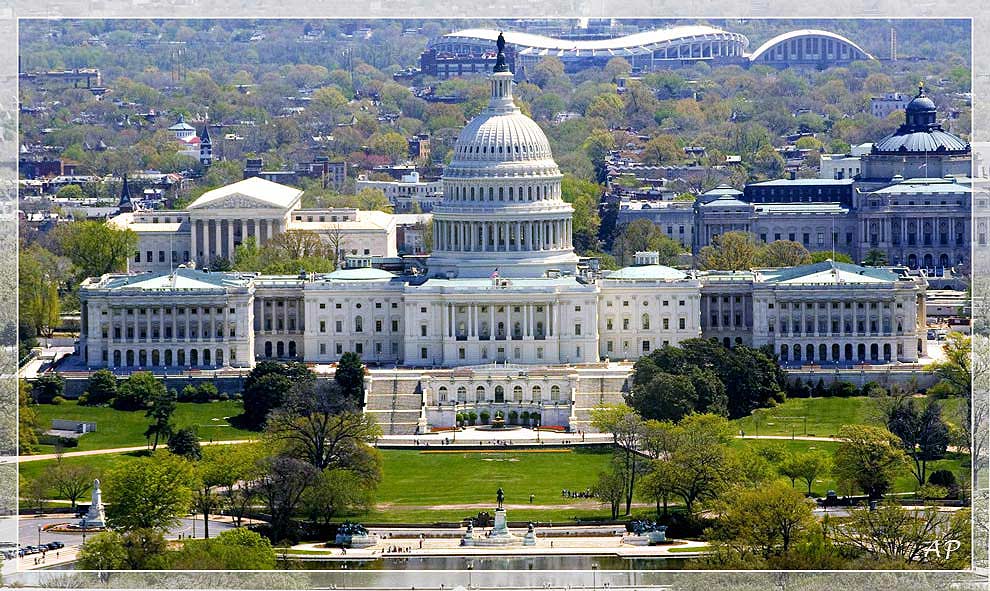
[709,483,816,560]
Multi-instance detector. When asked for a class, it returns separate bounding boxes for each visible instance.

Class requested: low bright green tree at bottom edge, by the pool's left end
[169,528,276,570]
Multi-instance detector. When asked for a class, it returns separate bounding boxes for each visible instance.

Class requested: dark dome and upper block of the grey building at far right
[859,85,972,183]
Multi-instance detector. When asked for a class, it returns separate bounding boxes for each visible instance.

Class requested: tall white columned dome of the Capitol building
[429,33,577,277]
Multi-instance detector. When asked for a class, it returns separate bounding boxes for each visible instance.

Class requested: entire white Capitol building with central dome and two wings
[78,39,925,433]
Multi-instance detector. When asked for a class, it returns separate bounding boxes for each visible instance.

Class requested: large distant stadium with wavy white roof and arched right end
[420,25,873,79]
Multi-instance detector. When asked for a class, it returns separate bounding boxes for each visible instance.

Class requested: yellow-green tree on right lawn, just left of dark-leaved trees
[833,425,907,499]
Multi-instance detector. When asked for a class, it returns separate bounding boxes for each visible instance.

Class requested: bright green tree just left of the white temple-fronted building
[56,221,138,277]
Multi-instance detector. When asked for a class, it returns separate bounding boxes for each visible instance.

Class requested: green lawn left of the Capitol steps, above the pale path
[33,400,258,454]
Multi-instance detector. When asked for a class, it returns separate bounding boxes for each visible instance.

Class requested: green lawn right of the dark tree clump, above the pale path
[732,396,965,437]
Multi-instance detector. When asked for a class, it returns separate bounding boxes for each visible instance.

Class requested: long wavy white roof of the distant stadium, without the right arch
[444,25,749,55]
